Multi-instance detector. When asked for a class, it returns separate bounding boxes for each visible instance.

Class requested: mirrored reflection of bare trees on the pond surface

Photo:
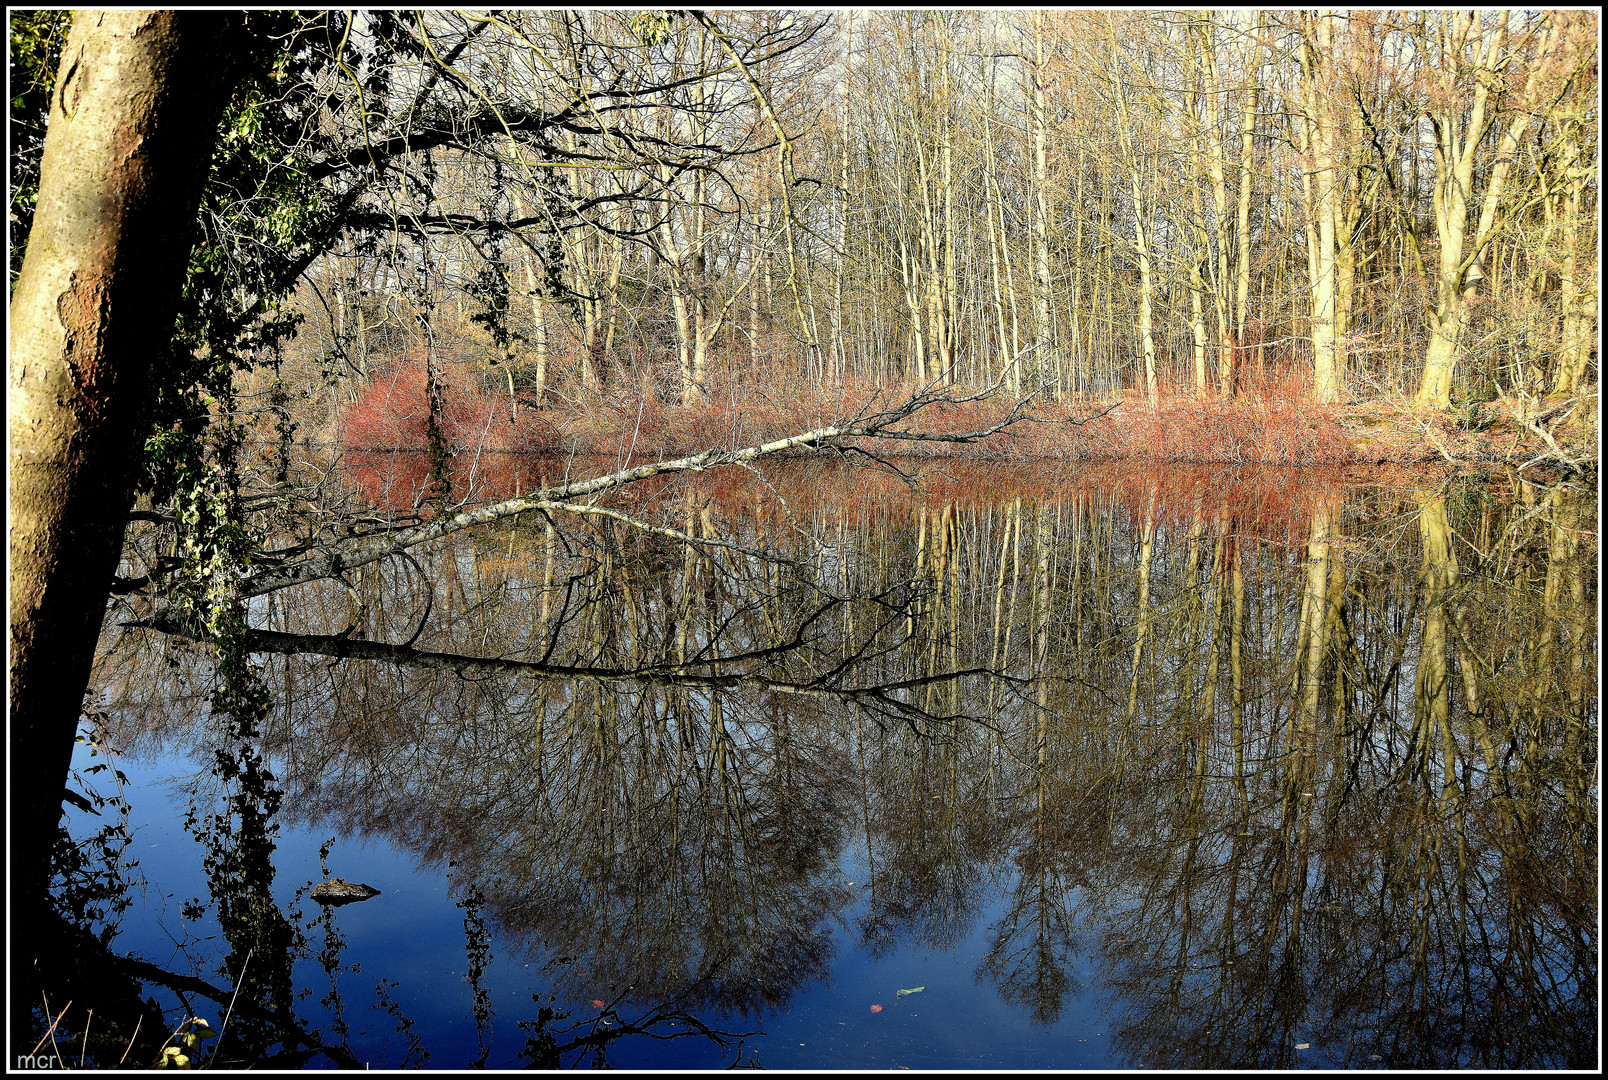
[103,462,1597,1067]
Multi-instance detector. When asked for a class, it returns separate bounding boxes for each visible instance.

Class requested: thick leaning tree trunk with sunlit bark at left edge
[6,10,244,1035]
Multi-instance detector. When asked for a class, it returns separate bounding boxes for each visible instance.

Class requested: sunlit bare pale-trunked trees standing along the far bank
[257,10,1598,437]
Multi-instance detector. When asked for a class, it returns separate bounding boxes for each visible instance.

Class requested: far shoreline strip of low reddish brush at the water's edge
[323,385,1598,476]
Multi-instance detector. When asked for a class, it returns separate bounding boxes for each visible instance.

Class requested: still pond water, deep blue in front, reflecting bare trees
[63,456,1598,1070]
